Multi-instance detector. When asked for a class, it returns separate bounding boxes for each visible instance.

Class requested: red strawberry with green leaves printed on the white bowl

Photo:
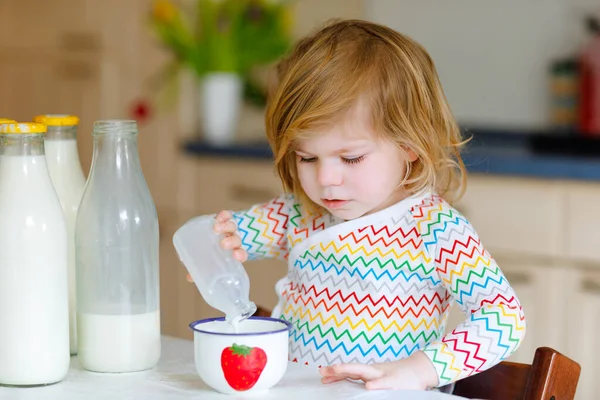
[221,343,267,391]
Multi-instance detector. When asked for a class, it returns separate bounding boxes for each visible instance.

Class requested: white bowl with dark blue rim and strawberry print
[190,317,291,394]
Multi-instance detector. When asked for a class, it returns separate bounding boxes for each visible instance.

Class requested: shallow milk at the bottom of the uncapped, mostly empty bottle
[77,310,160,372]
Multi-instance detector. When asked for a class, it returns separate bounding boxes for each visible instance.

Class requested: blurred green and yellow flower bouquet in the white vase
[150,0,293,107]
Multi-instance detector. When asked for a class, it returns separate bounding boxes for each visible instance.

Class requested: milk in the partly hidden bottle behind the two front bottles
[44,139,85,354]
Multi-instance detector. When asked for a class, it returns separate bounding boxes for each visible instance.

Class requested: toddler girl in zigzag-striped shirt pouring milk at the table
[196,20,525,389]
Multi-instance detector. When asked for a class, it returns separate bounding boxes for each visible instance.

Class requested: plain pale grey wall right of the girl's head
[365,0,600,127]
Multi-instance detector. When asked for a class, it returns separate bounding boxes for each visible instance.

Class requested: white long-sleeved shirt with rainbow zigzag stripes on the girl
[234,194,525,386]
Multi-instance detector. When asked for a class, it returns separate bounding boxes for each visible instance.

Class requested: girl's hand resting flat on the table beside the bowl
[320,351,438,390]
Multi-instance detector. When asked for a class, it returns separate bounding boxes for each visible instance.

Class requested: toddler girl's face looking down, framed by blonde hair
[296,103,416,220]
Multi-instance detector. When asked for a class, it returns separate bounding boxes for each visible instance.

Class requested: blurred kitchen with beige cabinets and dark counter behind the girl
[0,0,600,399]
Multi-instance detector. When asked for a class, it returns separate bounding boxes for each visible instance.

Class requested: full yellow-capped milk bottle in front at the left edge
[0,123,70,386]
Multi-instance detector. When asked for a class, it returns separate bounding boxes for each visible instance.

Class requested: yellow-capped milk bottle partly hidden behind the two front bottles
[34,115,85,354]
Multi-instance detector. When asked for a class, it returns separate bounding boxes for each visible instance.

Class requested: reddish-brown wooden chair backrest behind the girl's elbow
[453,347,581,400]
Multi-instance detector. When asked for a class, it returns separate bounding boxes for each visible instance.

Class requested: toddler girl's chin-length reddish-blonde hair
[265,20,466,209]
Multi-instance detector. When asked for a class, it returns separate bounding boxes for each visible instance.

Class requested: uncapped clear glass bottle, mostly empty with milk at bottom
[75,120,161,372]
